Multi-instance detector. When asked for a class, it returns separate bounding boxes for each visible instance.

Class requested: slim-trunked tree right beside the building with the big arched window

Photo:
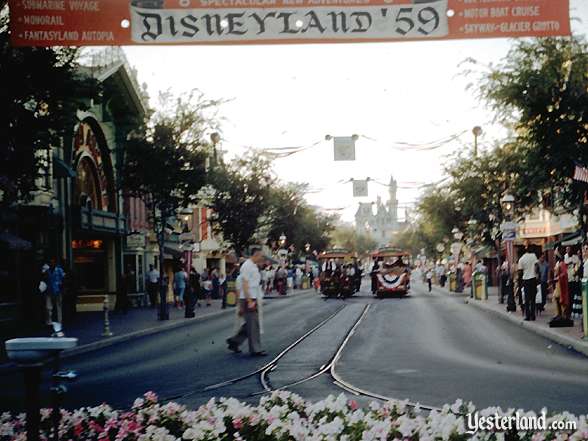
[121,92,218,320]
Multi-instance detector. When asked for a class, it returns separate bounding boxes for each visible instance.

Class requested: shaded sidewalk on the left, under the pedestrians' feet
[0,289,314,373]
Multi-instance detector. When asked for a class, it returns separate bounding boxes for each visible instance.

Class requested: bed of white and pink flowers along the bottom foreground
[0,392,588,441]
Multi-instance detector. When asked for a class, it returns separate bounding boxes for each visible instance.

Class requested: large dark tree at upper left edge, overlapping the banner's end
[0,11,100,211]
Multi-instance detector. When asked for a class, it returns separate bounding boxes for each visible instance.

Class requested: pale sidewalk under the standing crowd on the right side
[433,286,588,355]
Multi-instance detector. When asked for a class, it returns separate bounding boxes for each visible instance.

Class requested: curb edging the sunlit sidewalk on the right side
[424,286,588,356]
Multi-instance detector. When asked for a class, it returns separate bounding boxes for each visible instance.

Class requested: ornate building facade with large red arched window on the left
[0,48,147,328]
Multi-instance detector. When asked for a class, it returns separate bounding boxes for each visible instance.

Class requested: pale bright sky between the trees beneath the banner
[125,0,588,222]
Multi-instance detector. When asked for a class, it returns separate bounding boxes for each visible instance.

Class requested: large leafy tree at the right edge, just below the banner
[478,37,588,223]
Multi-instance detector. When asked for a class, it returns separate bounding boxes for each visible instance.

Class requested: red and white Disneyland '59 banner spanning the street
[9,0,570,46]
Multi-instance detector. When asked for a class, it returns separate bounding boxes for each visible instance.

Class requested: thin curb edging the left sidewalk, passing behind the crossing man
[0,290,314,375]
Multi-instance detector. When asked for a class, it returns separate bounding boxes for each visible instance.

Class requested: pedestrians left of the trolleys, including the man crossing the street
[38,249,318,355]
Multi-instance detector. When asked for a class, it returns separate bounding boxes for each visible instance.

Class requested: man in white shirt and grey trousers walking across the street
[227,248,267,356]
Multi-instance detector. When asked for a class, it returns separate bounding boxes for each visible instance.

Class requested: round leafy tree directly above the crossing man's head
[209,151,275,255]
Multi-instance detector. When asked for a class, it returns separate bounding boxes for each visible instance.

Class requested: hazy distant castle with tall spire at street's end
[355,177,404,246]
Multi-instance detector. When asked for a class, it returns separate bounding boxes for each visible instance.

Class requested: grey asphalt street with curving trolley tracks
[0,283,588,414]
